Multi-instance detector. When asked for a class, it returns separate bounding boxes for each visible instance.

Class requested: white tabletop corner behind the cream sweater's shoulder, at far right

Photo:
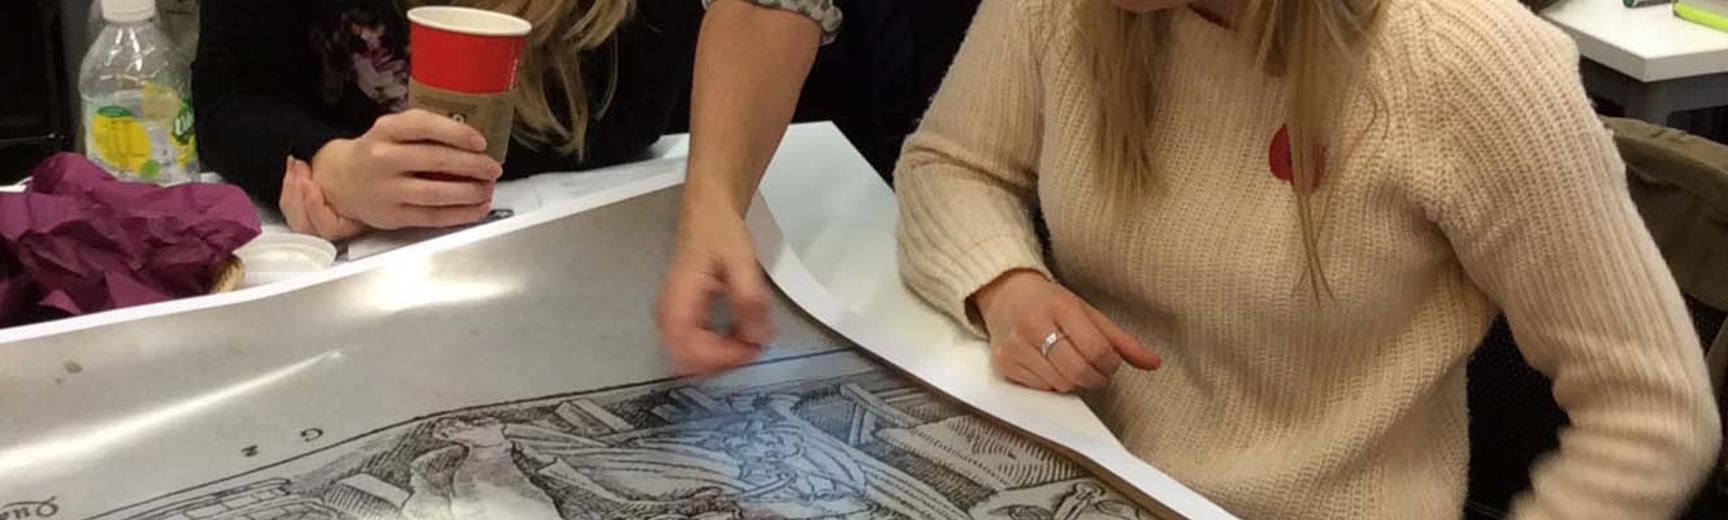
[1541,0,1728,83]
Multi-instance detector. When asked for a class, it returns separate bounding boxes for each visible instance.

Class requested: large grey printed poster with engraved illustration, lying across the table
[0,183,1175,520]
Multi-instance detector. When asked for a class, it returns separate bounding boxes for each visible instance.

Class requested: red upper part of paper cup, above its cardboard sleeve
[408,7,534,93]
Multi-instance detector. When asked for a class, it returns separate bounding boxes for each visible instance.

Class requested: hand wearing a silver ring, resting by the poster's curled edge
[973,271,1159,394]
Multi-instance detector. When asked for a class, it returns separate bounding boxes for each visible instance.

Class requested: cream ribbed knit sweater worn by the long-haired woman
[899,0,1721,520]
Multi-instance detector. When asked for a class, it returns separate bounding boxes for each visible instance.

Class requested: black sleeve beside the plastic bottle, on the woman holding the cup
[192,0,354,206]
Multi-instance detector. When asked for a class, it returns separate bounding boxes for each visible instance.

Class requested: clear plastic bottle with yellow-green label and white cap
[78,0,199,185]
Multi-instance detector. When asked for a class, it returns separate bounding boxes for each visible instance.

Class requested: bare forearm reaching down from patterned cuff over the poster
[684,2,823,212]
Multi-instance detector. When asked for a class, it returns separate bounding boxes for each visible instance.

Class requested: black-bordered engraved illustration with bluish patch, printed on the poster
[107,351,1153,520]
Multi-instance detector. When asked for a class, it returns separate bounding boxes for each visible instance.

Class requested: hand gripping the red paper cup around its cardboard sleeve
[313,111,503,230]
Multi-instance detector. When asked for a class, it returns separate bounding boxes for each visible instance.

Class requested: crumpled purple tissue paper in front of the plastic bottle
[0,154,261,327]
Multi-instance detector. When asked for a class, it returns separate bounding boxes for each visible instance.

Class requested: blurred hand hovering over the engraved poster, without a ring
[655,197,774,375]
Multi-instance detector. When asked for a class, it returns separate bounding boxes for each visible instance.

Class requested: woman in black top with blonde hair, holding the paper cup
[192,0,703,238]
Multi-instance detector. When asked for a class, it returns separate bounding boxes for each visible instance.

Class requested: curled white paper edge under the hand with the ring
[748,126,1232,518]
